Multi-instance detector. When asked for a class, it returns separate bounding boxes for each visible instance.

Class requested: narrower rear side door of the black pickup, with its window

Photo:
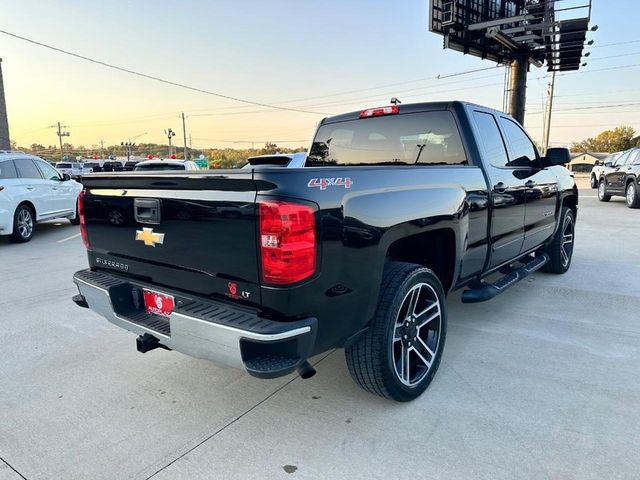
[473,110,527,267]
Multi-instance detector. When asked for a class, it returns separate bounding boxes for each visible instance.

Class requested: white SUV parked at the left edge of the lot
[0,150,82,242]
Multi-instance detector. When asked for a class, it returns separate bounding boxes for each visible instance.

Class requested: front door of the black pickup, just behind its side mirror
[500,116,558,251]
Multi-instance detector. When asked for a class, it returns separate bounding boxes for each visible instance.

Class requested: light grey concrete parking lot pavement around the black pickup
[0,189,640,480]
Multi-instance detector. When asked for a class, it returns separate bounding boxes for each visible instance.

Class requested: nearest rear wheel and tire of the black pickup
[345,262,447,402]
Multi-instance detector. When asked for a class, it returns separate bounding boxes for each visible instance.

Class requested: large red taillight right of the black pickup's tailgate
[259,201,316,285]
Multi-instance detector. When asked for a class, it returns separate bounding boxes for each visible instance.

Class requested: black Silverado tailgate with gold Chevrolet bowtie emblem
[84,172,259,303]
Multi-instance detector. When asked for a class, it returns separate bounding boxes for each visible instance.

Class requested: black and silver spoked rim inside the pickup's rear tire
[391,283,441,387]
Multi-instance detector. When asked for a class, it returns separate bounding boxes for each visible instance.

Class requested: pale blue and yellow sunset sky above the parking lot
[0,0,640,148]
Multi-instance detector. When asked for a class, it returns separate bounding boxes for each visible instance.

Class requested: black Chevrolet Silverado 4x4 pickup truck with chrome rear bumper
[73,102,578,401]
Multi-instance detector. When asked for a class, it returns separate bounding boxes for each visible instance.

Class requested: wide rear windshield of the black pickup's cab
[306,111,467,167]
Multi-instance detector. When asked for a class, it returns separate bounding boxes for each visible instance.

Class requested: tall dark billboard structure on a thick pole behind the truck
[429,0,595,123]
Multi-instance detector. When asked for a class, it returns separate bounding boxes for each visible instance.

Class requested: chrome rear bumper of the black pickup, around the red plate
[73,270,317,378]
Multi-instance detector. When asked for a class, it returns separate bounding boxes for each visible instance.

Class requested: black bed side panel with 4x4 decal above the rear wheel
[255,166,487,351]
